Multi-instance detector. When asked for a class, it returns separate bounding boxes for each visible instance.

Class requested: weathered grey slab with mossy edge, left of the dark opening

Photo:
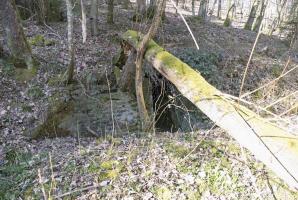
[26,84,138,139]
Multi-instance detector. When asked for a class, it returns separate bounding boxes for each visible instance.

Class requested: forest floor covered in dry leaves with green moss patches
[0,3,298,199]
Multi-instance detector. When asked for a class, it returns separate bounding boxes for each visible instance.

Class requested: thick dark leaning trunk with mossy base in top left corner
[0,0,35,69]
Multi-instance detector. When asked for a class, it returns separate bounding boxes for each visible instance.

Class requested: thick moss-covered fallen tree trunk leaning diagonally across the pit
[122,31,298,190]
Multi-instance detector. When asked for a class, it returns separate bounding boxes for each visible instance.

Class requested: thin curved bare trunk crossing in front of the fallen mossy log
[135,0,166,130]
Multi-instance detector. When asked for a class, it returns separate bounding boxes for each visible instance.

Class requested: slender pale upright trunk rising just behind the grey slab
[66,0,75,83]
